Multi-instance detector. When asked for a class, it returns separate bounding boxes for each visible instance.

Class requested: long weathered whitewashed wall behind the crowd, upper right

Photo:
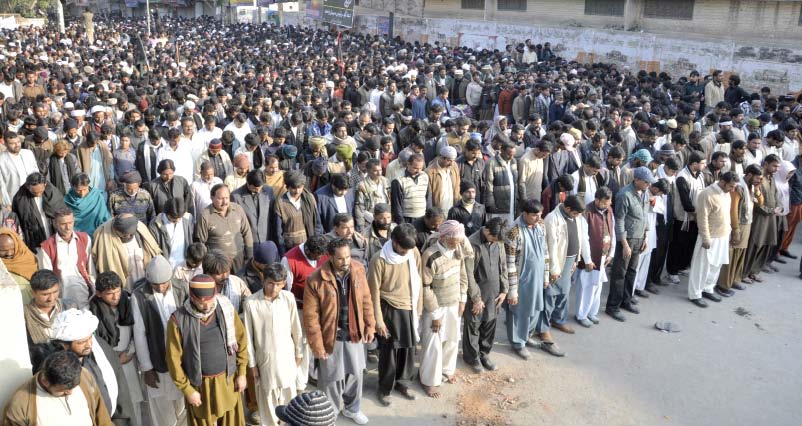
[355,14,802,93]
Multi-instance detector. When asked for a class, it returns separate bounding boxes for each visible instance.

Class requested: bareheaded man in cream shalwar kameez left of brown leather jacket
[242,263,304,426]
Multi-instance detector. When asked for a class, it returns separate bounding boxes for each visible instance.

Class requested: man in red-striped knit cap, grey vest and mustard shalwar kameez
[167,274,248,426]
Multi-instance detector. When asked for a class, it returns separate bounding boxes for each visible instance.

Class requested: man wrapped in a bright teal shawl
[64,173,111,236]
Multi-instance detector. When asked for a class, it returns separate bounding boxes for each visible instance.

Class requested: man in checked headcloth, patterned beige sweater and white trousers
[420,220,473,398]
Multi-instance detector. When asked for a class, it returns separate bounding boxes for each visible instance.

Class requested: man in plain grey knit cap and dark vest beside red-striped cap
[131,256,188,425]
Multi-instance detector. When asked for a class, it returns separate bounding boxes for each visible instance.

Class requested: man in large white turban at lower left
[52,309,133,426]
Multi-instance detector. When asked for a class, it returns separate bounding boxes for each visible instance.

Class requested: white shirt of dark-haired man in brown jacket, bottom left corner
[36,383,92,426]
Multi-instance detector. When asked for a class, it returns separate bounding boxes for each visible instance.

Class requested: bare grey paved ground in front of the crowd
[338,240,802,426]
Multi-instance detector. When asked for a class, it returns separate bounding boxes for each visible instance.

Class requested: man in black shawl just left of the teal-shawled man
[12,172,67,250]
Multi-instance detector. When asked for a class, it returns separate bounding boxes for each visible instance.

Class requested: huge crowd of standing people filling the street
[0,12,802,426]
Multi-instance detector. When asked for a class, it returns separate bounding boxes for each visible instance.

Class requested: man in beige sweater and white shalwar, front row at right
[688,172,738,308]
